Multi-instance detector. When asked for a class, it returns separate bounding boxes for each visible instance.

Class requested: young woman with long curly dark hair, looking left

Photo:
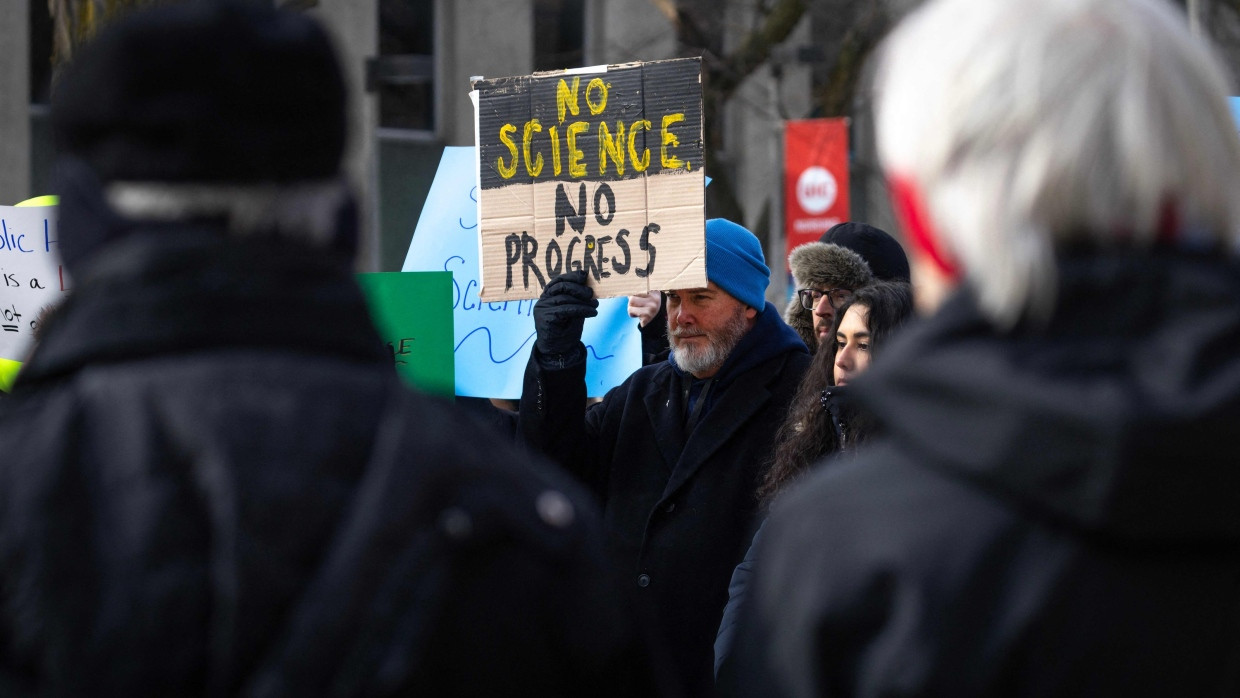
[714,281,913,683]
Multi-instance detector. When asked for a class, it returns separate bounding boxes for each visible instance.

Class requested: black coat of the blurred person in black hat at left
[0,231,653,697]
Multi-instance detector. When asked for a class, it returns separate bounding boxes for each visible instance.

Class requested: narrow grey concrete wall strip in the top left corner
[0,0,31,206]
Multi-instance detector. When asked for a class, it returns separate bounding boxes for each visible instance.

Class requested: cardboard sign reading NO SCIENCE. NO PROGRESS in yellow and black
[472,58,707,301]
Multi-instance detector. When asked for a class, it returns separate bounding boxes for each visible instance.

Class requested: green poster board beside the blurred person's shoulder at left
[357,272,456,397]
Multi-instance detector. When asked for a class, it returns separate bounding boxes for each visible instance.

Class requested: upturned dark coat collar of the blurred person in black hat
[15,228,388,391]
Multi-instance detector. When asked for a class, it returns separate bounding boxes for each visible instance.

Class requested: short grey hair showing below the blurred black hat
[105,179,348,247]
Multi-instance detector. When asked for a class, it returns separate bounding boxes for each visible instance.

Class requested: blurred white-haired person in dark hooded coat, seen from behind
[735,0,1240,697]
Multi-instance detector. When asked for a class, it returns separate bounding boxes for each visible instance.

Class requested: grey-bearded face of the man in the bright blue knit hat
[667,281,758,378]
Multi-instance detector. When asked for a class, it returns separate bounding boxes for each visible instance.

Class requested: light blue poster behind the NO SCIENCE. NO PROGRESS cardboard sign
[402,148,641,399]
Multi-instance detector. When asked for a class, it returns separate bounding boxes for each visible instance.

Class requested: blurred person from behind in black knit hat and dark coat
[0,0,653,697]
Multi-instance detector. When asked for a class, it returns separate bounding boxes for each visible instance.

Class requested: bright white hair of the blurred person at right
[875,0,1240,326]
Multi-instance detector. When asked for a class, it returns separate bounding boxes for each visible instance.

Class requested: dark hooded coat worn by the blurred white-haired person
[735,250,1240,697]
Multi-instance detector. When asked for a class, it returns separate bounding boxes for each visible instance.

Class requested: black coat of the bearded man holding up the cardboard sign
[521,304,810,696]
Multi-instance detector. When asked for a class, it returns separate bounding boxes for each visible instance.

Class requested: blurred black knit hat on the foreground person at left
[52,0,346,182]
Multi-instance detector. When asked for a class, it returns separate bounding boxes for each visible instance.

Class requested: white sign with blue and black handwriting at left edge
[0,206,69,361]
